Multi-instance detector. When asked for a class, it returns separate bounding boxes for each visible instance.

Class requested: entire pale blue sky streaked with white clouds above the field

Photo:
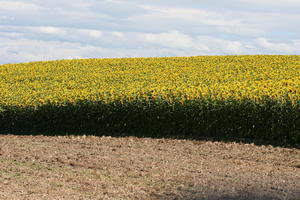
[0,0,300,64]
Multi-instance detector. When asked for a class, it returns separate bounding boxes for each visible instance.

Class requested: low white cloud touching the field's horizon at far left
[0,38,111,63]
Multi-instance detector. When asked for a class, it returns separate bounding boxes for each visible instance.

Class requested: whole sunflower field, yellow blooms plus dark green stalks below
[0,55,300,145]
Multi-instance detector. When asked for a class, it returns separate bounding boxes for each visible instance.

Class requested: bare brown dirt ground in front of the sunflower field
[0,135,300,200]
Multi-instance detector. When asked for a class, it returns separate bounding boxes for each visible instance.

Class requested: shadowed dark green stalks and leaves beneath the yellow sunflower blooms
[0,98,300,146]
